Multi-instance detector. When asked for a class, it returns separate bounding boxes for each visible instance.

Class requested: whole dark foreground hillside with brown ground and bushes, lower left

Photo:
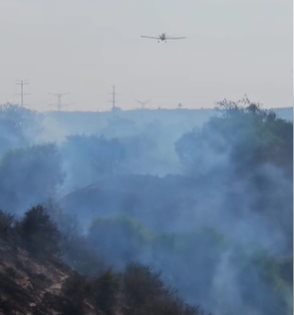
[0,206,203,315]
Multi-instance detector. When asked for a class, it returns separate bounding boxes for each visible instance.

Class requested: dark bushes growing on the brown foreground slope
[0,206,204,315]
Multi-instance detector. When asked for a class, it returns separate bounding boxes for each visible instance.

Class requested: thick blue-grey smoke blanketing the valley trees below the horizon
[0,105,293,315]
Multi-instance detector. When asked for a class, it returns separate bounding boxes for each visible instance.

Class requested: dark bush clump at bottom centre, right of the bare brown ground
[63,264,204,315]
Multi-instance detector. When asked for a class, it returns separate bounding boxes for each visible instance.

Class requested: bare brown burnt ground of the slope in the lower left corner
[0,241,97,315]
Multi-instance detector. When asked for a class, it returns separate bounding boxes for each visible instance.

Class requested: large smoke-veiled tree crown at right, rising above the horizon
[176,100,293,176]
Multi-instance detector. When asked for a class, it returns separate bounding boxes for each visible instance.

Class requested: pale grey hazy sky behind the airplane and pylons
[0,0,293,110]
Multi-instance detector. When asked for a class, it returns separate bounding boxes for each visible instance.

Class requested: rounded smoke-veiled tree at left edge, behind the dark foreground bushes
[0,144,63,214]
